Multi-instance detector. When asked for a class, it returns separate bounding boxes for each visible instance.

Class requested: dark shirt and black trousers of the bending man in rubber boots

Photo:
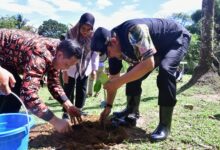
[109,19,190,106]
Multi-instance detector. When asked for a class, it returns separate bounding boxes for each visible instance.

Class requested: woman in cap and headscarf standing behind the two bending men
[63,13,99,119]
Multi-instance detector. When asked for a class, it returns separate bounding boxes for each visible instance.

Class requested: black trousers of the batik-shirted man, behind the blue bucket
[0,69,22,113]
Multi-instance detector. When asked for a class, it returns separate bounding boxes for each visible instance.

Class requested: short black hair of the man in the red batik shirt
[57,39,82,59]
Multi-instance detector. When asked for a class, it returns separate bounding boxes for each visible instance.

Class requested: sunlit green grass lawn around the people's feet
[35,72,220,150]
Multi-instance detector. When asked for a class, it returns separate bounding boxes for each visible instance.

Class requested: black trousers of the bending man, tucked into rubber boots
[126,35,190,107]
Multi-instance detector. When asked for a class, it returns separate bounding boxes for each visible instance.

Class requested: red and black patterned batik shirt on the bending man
[0,29,68,121]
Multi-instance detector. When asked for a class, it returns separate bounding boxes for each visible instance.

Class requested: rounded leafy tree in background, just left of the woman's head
[38,19,68,38]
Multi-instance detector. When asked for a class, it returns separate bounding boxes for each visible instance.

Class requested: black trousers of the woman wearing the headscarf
[64,76,88,111]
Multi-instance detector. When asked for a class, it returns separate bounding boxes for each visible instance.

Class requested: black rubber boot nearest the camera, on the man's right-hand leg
[150,106,174,142]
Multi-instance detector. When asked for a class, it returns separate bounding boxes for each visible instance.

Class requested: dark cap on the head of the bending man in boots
[91,27,111,55]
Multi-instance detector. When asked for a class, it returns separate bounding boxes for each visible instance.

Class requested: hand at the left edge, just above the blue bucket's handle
[0,67,16,95]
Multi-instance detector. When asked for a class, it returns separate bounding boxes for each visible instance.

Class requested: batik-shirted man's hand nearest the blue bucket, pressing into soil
[49,116,72,133]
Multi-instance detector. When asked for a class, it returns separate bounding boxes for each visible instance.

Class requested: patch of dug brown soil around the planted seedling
[29,116,146,150]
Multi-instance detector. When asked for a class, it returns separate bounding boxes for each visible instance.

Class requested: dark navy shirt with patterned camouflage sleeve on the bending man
[109,18,189,75]
